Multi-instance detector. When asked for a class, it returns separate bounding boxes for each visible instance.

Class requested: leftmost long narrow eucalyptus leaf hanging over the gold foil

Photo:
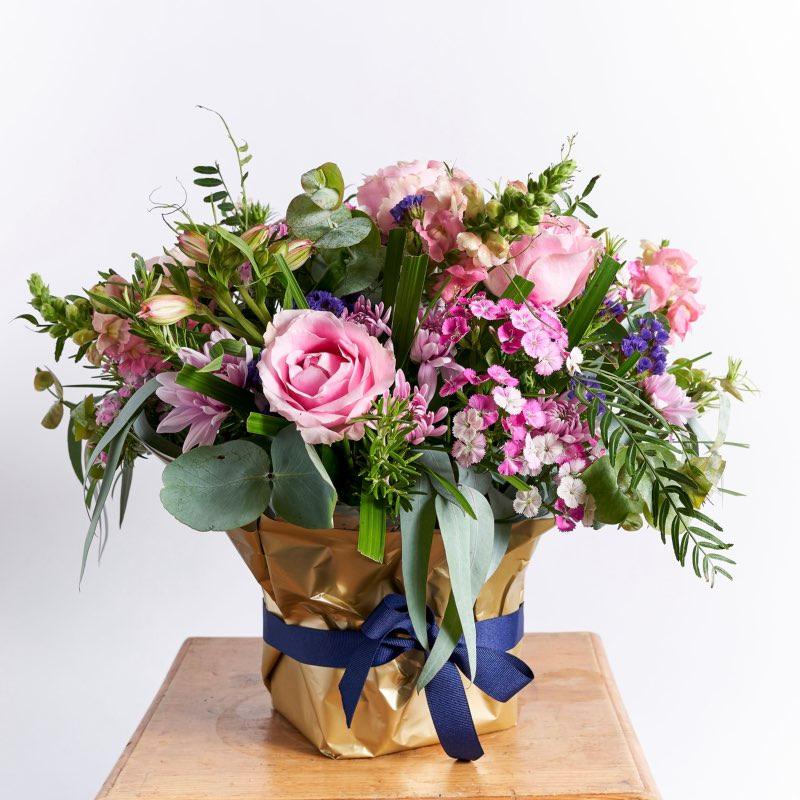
[400,475,438,649]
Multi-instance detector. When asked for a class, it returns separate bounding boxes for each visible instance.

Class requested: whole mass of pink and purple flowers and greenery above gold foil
[23,117,750,756]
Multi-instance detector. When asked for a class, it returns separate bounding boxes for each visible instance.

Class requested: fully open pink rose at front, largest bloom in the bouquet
[258,309,395,444]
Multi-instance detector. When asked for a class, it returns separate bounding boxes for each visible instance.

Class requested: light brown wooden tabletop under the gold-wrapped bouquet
[98,633,659,800]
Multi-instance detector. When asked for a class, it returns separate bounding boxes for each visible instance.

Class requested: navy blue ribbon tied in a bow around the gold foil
[264,594,533,761]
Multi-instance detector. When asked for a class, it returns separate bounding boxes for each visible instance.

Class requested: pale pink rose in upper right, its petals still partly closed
[484,216,602,308]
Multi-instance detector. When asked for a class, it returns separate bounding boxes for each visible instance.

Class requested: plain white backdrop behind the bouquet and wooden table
[0,0,800,800]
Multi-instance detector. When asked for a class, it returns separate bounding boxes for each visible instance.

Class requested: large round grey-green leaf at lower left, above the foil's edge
[161,439,270,531]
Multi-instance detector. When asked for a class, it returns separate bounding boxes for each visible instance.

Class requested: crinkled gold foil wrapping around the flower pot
[228,515,553,758]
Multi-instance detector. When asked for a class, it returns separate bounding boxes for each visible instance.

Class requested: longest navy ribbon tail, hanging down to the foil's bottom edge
[425,661,483,761]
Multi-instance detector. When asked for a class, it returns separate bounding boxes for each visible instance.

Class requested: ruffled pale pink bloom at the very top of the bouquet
[357,161,470,233]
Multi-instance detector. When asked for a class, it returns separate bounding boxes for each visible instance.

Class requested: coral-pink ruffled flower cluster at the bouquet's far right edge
[628,247,705,339]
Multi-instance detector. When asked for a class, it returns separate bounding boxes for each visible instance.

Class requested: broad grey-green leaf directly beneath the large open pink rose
[270,425,336,528]
